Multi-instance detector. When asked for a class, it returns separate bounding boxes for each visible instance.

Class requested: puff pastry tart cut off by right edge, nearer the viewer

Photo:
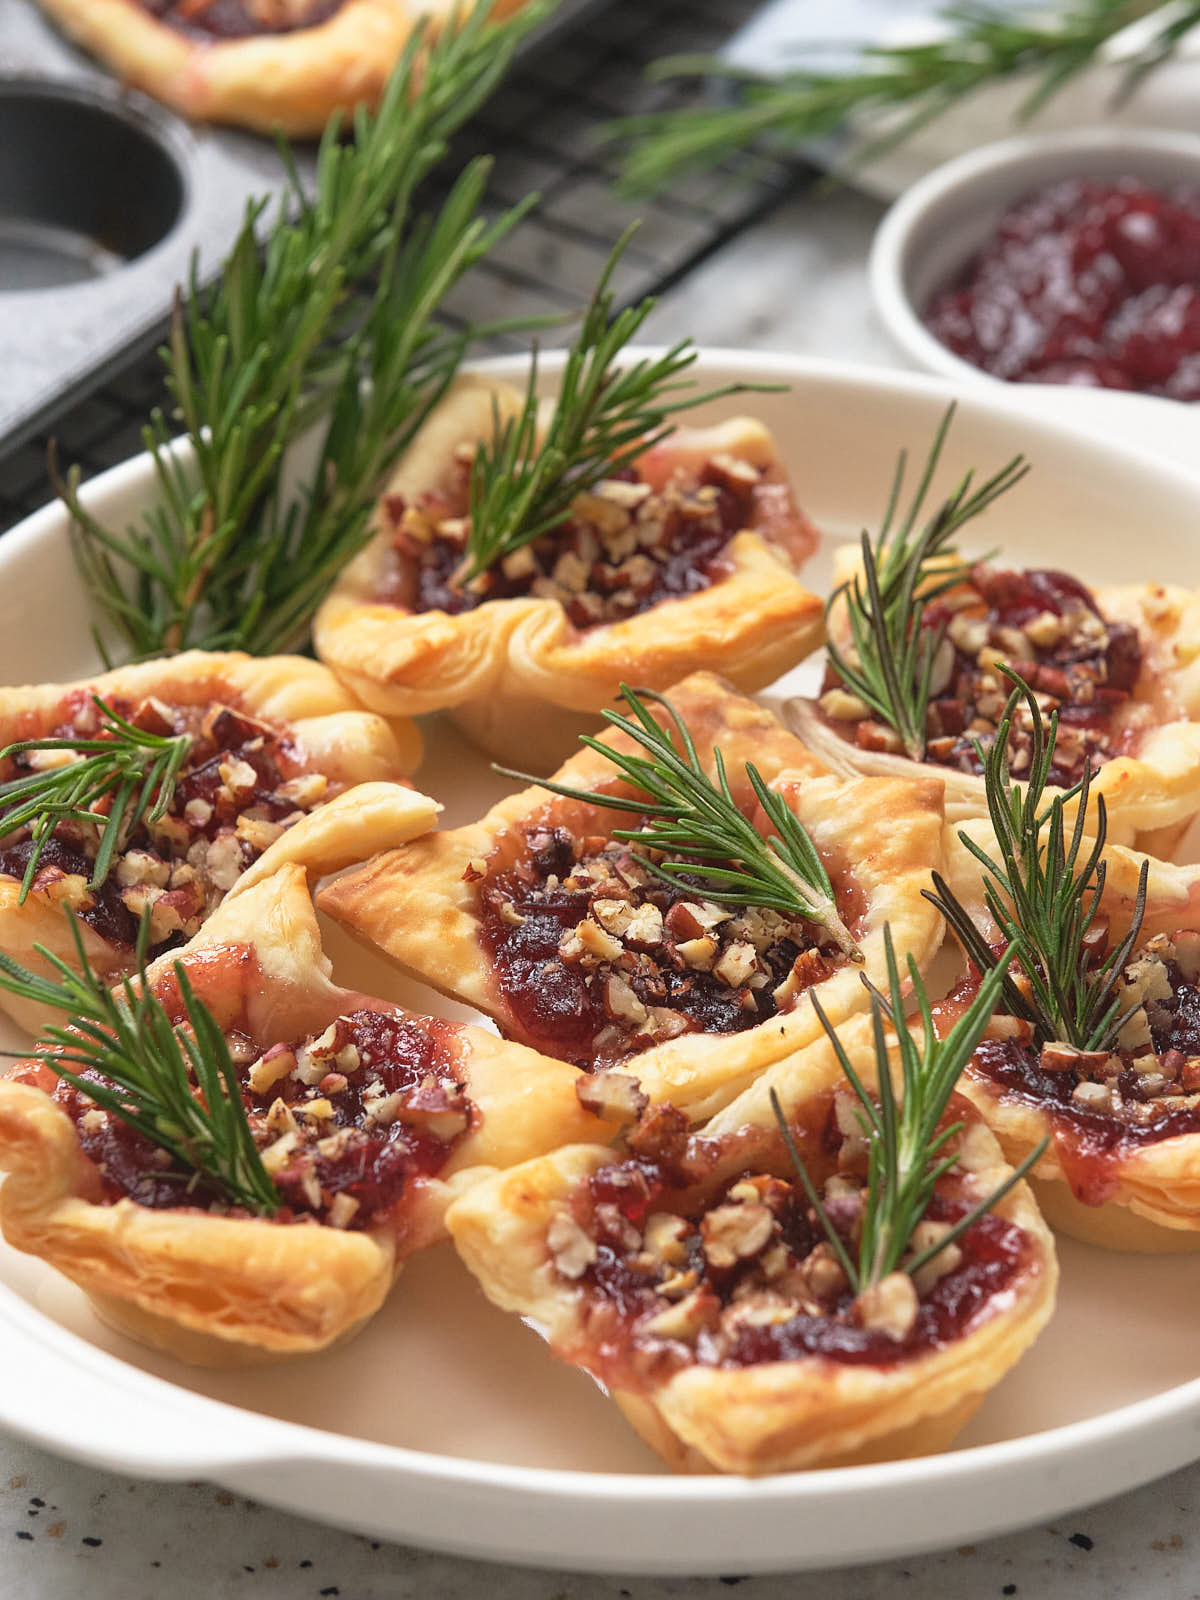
[938,821,1200,1251]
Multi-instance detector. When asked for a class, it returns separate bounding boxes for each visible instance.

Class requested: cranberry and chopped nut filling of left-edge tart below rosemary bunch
[0,696,328,952]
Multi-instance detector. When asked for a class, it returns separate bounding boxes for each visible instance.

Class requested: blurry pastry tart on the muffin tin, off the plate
[30,0,522,134]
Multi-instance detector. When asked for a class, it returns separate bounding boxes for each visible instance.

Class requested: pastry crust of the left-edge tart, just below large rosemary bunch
[0,650,438,1032]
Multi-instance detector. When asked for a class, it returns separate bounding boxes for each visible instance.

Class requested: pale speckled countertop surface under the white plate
[0,181,1200,1600]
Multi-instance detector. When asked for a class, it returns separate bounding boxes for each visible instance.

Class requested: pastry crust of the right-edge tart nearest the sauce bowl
[786,546,1200,854]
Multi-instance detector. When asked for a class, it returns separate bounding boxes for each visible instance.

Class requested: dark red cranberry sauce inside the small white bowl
[925,178,1200,400]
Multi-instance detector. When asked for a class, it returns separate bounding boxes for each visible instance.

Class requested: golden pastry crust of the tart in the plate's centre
[318,672,941,1120]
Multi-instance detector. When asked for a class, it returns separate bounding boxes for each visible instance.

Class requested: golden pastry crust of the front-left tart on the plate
[0,864,611,1365]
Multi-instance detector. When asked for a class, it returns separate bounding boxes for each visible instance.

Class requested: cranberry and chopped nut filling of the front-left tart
[54,1010,472,1229]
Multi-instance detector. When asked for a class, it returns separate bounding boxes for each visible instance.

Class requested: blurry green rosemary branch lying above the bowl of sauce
[613,0,1200,194]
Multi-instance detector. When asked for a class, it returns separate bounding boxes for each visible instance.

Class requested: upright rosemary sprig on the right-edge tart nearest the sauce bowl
[826,405,1029,762]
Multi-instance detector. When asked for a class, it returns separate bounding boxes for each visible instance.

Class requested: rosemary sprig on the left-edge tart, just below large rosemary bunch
[0,694,192,904]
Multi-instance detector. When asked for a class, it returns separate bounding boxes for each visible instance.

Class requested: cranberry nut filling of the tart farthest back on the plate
[378,454,778,629]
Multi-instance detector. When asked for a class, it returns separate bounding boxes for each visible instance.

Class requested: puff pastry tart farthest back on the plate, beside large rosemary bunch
[314,378,824,771]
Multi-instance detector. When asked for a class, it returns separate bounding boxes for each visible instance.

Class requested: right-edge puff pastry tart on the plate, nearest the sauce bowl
[787,547,1200,854]
